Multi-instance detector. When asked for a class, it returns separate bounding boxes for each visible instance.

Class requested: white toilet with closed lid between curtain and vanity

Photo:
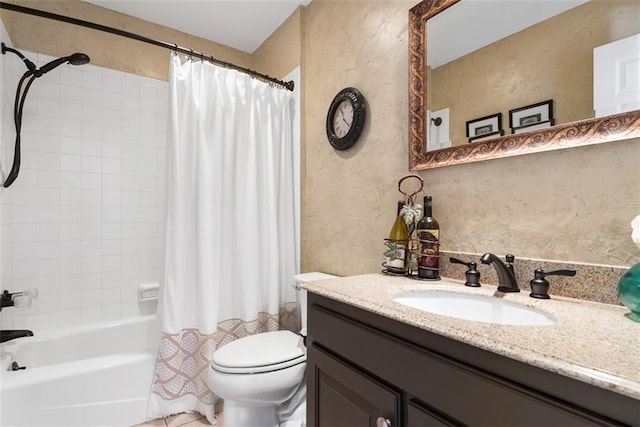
[207,272,337,427]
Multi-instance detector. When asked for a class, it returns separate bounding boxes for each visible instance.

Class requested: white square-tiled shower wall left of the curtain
[0,43,168,331]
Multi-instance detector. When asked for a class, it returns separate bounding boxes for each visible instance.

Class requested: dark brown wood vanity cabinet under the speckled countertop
[307,294,640,427]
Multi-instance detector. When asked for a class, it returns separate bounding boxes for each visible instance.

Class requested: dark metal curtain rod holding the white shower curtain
[0,1,294,91]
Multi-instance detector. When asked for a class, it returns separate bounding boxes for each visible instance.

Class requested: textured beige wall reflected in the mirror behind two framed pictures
[428,0,640,145]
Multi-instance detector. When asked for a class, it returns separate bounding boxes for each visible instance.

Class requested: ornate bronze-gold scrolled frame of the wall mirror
[409,0,640,171]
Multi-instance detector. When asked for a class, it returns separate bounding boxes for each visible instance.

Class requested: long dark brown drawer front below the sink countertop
[309,305,613,426]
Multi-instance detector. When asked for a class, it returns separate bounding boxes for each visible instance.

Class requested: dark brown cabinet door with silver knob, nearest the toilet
[307,345,400,427]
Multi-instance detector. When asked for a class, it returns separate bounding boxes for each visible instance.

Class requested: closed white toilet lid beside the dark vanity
[211,331,306,373]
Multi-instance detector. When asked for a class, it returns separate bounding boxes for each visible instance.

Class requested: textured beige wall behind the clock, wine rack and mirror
[302,0,640,275]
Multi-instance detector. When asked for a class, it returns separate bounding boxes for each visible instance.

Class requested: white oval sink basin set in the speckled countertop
[393,290,556,326]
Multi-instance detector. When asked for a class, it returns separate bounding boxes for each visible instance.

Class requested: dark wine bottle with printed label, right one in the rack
[416,196,440,280]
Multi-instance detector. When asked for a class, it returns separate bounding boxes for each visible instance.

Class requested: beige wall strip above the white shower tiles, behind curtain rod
[0,0,253,80]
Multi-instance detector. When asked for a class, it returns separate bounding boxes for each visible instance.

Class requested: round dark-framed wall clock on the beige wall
[327,87,367,150]
